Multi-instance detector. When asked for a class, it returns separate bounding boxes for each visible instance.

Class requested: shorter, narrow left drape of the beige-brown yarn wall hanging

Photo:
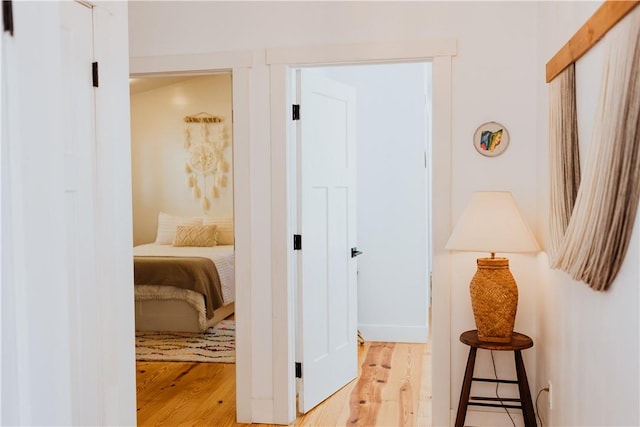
[548,64,580,263]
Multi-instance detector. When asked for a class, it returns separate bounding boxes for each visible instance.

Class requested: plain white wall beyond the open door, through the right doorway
[326,63,429,342]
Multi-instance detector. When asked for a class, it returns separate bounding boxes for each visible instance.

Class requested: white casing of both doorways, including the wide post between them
[130,39,457,425]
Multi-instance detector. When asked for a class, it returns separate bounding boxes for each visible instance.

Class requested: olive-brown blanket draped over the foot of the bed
[133,256,223,319]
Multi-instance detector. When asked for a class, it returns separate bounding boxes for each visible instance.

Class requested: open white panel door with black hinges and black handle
[297,70,358,413]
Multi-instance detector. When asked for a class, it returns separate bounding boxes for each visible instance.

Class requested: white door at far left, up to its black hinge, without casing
[2,2,104,425]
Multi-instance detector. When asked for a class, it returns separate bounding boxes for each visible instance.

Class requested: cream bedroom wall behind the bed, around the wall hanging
[131,73,233,245]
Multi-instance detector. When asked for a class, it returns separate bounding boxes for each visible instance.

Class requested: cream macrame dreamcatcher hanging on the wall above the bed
[184,113,230,211]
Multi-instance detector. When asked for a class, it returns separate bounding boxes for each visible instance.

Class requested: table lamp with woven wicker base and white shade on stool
[445,191,540,342]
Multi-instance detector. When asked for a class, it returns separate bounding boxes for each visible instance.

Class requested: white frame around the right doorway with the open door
[266,39,457,425]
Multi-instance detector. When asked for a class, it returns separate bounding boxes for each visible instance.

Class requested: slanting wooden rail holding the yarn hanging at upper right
[547,0,640,83]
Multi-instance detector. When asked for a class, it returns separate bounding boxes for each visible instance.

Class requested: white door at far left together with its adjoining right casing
[0,1,136,426]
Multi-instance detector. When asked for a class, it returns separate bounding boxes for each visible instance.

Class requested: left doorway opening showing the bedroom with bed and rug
[130,71,236,424]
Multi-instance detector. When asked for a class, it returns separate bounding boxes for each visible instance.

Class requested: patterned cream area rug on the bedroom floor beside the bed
[136,320,236,363]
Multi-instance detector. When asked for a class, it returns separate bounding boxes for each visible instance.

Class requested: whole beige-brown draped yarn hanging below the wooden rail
[549,2,640,291]
